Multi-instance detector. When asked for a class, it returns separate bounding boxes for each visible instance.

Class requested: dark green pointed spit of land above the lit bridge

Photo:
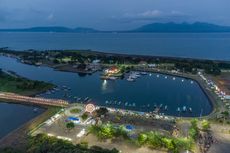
[0,70,54,95]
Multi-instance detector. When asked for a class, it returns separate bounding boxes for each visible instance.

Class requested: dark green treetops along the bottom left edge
[0,134,118,153]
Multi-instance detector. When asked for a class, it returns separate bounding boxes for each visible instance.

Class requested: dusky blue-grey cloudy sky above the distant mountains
[0,0,230,30]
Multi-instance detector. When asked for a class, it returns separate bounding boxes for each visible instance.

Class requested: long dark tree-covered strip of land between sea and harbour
[0,49,230,75]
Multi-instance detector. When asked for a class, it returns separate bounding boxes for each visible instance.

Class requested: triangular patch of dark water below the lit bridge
[0,102,43,138]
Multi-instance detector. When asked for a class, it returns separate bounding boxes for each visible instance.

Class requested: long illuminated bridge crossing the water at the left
[0,92,69,107]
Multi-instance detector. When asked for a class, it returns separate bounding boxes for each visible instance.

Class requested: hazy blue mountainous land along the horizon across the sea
[0,22,230,33]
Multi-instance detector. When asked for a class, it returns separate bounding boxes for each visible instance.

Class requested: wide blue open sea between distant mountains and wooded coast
[0,33,230,60]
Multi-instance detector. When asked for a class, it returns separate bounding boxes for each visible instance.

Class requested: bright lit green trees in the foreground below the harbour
[89,124,193,153]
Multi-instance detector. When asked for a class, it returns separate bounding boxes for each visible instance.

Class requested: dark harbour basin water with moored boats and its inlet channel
[0,57,212,116]
